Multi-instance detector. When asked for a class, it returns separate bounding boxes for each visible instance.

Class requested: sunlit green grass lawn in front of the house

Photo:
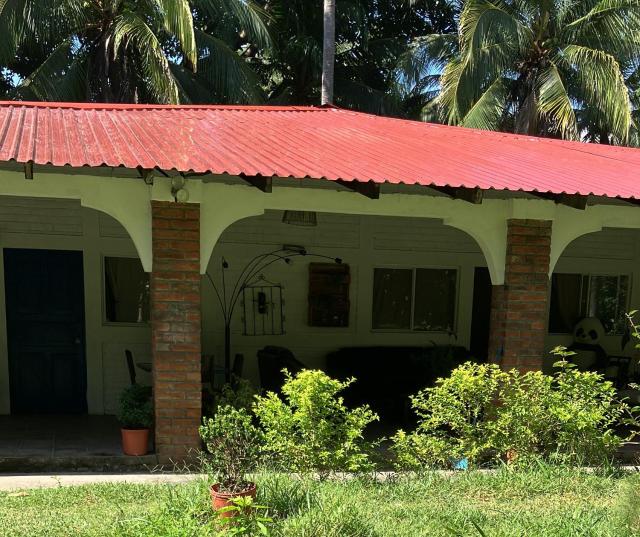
[0,467,640,537]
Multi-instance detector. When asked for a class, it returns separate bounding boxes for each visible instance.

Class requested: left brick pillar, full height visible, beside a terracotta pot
[151,201,202,462]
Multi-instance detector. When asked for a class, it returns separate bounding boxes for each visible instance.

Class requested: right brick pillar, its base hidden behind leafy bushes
[489,219,551,371]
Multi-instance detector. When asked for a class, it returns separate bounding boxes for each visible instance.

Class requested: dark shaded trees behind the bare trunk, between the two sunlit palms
[259,0,453,116]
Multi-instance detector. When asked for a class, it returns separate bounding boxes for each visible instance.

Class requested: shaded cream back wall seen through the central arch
[202,211,486,382]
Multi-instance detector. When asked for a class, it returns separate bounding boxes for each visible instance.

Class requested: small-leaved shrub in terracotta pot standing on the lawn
[200,405,262,517]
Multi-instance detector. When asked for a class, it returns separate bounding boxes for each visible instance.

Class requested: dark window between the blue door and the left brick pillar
[104,257,149,323]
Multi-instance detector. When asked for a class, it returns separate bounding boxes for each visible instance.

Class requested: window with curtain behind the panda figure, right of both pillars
[549,274,630,334]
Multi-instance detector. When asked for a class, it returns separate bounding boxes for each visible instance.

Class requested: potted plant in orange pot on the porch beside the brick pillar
[118,384,153,456]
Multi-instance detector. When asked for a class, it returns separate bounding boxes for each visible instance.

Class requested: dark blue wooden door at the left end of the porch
[4,248,87,414]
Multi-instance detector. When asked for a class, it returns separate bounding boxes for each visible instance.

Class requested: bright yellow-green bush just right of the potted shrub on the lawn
[254,370,378,477]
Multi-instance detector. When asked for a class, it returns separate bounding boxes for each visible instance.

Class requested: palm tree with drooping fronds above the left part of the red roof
[0,0,269,103]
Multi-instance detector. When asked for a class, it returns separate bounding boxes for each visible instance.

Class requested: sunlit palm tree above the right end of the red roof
[404,0,640,143]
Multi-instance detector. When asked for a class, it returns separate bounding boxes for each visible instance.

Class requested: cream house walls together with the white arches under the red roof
[0,172,640,414]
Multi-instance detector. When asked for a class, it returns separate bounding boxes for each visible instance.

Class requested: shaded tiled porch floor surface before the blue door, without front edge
[0,416,122,458]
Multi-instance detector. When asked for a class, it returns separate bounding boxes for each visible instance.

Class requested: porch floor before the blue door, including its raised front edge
[0,415,155,471]
